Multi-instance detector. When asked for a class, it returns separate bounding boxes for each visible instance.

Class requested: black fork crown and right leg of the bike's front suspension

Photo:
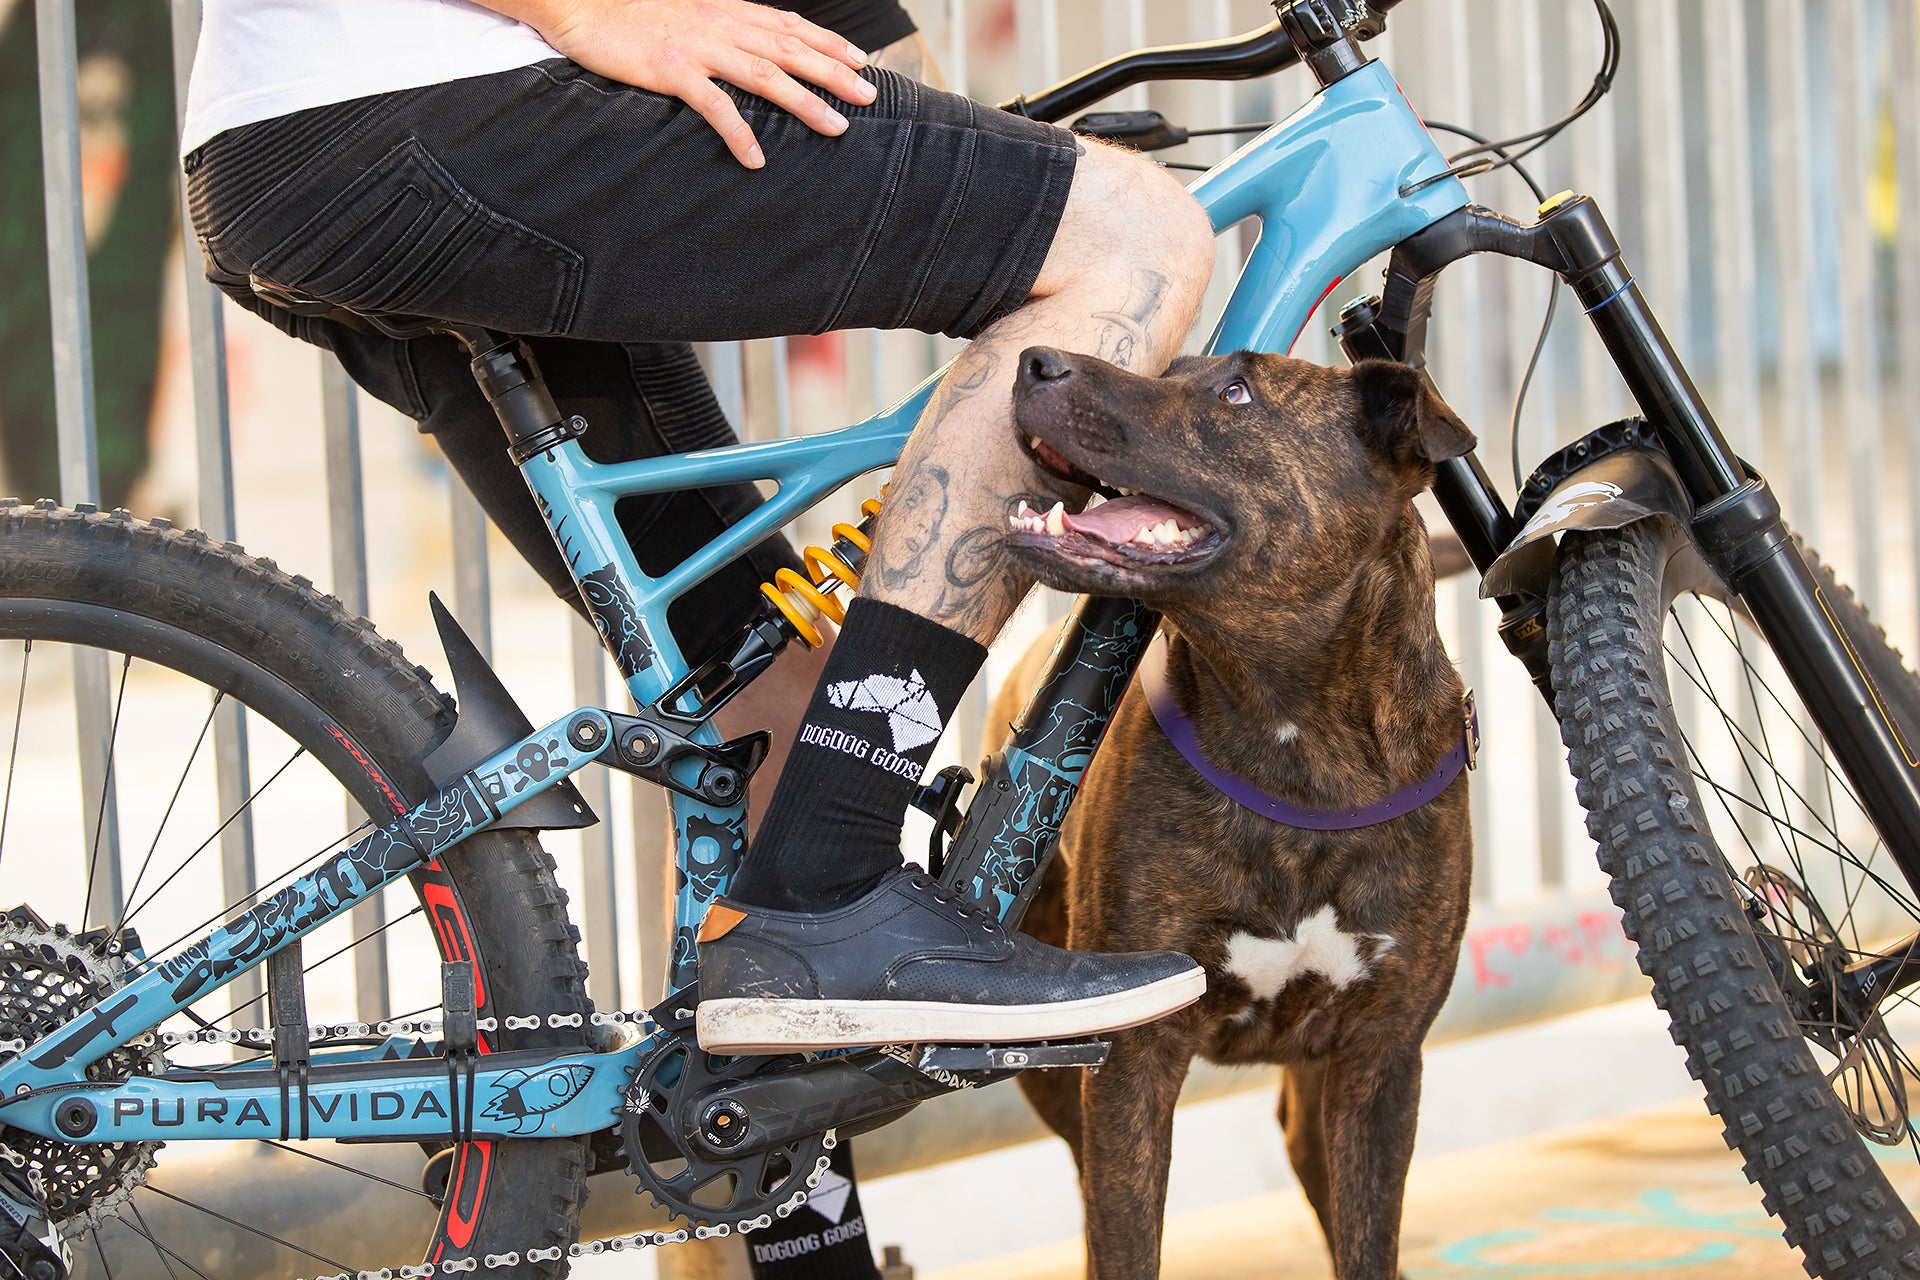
[1380,196,1920,921]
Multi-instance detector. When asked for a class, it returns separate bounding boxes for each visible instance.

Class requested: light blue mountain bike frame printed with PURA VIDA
[0,61,1467,1142]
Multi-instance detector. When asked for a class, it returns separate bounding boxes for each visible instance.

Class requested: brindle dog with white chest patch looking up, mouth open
[993,349,1475,1280]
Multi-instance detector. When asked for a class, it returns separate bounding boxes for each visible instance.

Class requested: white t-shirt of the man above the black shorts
[180,0,559,155]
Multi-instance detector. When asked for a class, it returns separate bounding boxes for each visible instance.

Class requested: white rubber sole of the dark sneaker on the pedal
[695,965,1206,1054]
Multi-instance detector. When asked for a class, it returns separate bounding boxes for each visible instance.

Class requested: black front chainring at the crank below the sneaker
[618,1029,835,1234]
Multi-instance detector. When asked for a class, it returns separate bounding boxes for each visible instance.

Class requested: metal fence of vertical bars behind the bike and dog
[22,0,1920,1205]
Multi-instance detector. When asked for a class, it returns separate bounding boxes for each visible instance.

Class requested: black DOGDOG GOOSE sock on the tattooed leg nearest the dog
[728,599,987,912]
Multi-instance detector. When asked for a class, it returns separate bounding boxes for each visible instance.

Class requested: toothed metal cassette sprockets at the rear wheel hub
[0,908,167,1232]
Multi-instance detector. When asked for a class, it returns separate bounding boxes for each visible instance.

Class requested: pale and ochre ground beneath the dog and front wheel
[840,1002,1873,1280]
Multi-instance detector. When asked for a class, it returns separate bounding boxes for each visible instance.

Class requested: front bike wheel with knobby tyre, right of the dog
[1549,522,1920,1280]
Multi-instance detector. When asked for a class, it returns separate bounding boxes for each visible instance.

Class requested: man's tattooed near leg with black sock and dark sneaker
[699,148,1213,1052]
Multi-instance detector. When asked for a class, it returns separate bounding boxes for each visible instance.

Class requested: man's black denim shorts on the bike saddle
[184,59,1077,654]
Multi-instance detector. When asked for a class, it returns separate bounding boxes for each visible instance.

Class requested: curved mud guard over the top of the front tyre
[1480,449,1732,599]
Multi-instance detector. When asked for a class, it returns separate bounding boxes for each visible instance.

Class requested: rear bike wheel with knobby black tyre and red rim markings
[0,503,588,1278]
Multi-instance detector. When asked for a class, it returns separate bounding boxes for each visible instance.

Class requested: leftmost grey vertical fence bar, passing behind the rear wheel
[35,0,121,925]
